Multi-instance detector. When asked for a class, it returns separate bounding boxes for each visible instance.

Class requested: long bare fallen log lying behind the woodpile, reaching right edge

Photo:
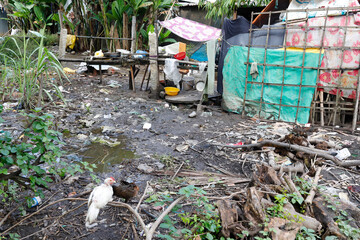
[214,140,360,167]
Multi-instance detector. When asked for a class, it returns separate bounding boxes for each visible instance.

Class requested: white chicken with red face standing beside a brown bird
[85,177,116,228]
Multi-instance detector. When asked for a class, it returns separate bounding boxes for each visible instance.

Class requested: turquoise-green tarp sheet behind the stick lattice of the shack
[222,46,322,124]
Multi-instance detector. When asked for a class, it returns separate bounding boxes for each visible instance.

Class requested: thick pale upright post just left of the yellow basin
[149,33,160,98]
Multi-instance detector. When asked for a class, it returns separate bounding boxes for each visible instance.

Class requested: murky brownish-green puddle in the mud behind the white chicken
[81,137,135,172]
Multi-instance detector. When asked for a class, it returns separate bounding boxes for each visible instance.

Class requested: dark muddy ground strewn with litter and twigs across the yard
[1,59,360,239]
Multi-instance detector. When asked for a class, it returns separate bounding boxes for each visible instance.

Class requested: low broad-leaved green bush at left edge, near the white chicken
[0,105,92,205]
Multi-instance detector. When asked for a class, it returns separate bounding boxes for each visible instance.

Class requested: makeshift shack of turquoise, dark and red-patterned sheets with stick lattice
[218,0,360,130]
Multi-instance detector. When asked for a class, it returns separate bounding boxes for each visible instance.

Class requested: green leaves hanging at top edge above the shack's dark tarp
[199,0,270,19]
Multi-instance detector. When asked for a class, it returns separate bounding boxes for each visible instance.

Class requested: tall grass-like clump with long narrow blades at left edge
[0,29,66,109]
